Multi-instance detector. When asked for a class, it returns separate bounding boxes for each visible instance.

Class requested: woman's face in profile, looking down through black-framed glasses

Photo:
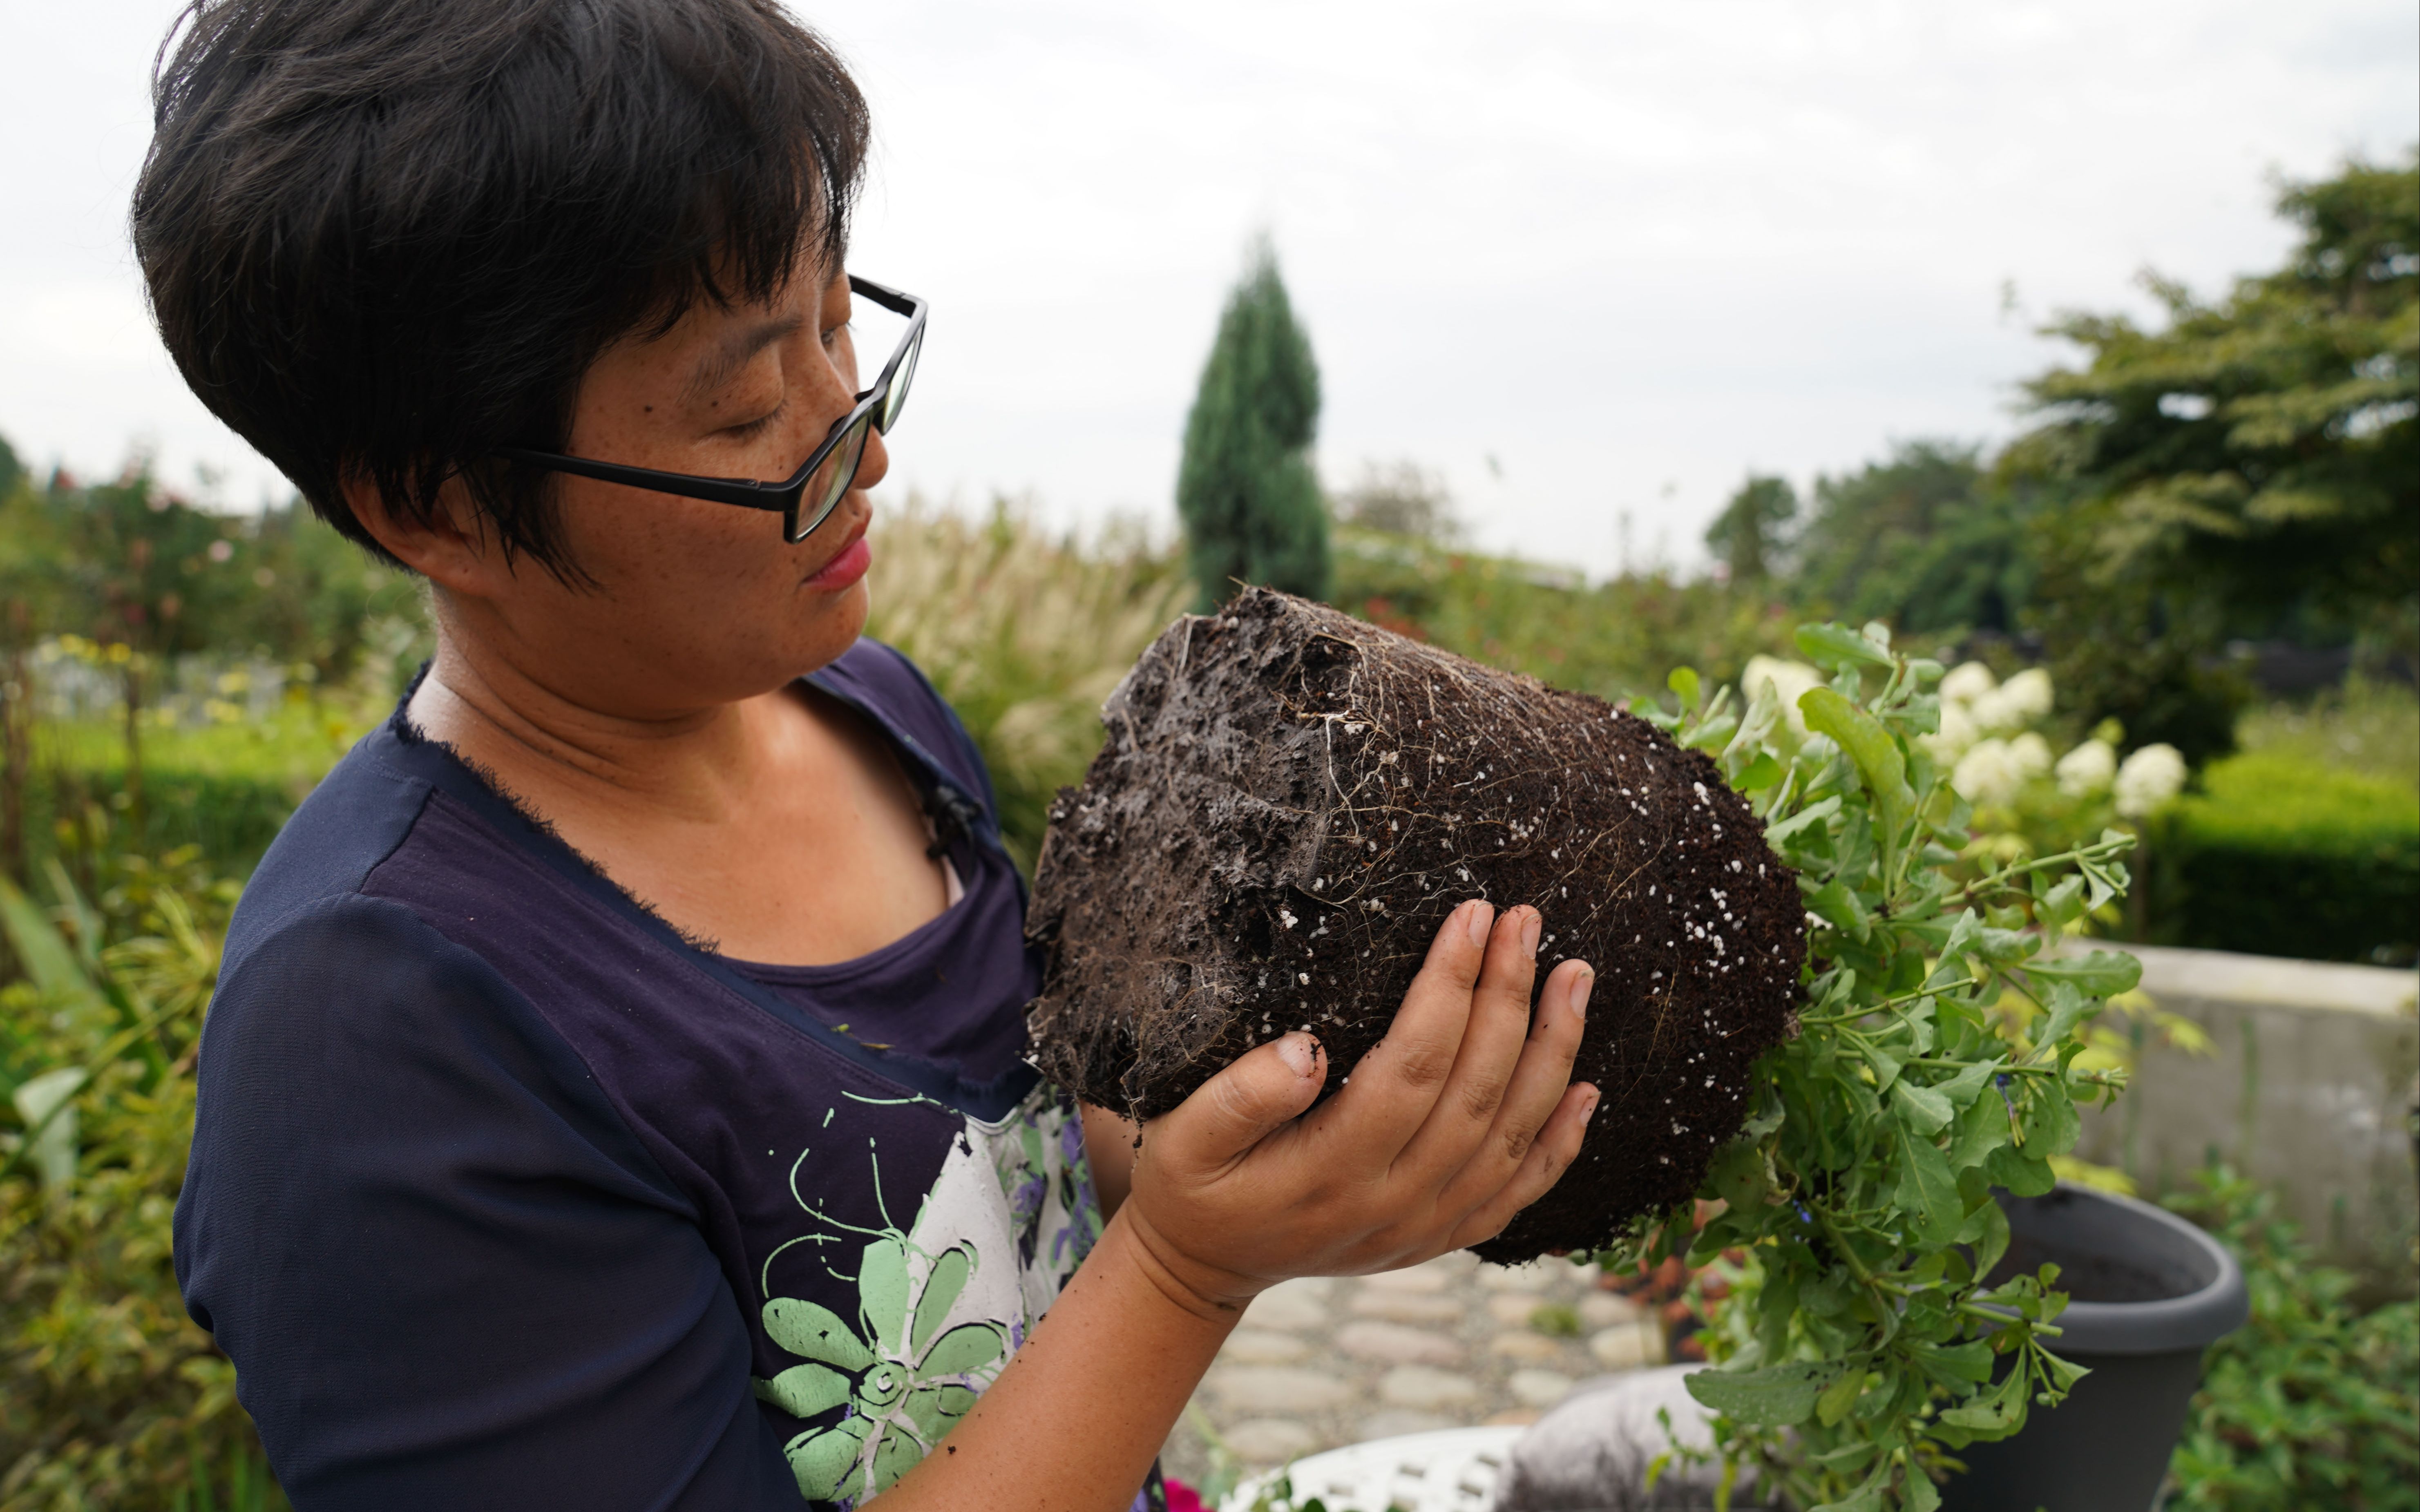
[457,262,891,719]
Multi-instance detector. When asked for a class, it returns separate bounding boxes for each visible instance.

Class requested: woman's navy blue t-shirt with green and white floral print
[177,641,1123,1512]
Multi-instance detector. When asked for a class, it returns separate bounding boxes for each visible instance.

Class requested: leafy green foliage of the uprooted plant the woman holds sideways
[1602,624,2139,1512]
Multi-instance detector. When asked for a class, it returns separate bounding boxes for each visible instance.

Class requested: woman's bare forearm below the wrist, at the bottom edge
[881,1217,1241,1512]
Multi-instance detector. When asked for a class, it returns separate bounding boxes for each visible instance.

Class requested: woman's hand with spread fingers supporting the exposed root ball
[1120,900,1597,1316]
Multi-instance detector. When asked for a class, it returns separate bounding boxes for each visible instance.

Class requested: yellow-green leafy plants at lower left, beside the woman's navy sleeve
[0,851,286,1512]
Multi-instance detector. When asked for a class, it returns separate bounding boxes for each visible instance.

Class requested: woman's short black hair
[133,0,869,576]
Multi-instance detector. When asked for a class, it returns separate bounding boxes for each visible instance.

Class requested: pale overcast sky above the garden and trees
[0,0,2420,571]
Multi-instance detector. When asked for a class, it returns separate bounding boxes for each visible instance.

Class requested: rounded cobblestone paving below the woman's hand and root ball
[1162,1253,1662,1481]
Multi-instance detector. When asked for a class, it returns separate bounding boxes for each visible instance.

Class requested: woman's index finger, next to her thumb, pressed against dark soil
[1319,898,1495,1168]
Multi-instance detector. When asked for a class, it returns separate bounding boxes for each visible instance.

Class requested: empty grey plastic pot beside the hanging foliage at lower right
[1941,1183,2250,1512]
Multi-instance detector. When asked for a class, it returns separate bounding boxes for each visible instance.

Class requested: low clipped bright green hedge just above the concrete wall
[2152,750,2420,963]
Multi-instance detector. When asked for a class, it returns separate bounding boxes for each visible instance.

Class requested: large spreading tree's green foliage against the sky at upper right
[2028,152,2420,610]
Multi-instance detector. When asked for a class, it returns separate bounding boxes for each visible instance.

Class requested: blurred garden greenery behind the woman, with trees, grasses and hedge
[0,59,2420,1512]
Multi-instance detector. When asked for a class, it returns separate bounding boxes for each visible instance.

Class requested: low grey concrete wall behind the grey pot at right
[2076,946,2420,1294]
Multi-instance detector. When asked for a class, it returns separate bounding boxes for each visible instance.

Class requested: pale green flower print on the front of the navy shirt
[755,1231,1009,1502]
